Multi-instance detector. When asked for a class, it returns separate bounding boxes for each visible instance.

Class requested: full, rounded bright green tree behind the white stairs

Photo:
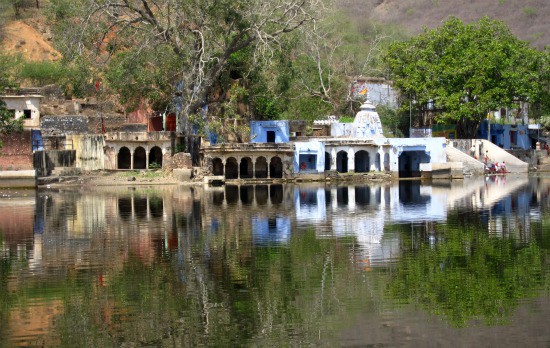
[386,17,545,138]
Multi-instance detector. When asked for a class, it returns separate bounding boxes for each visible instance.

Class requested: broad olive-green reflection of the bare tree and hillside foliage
[49,230,380,346]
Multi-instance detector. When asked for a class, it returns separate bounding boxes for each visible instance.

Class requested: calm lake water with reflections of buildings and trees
[0,175,550,347]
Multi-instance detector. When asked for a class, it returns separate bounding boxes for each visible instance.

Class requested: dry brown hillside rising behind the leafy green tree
[336,0,550,48]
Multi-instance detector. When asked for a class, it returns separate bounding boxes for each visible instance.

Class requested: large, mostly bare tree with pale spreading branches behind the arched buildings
[73,0,322,131]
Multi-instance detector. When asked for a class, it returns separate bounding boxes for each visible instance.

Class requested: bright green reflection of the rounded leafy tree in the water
[388,211,548,326]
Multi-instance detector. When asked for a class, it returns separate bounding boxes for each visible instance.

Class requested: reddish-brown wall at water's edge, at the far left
[0,131,33,170]
